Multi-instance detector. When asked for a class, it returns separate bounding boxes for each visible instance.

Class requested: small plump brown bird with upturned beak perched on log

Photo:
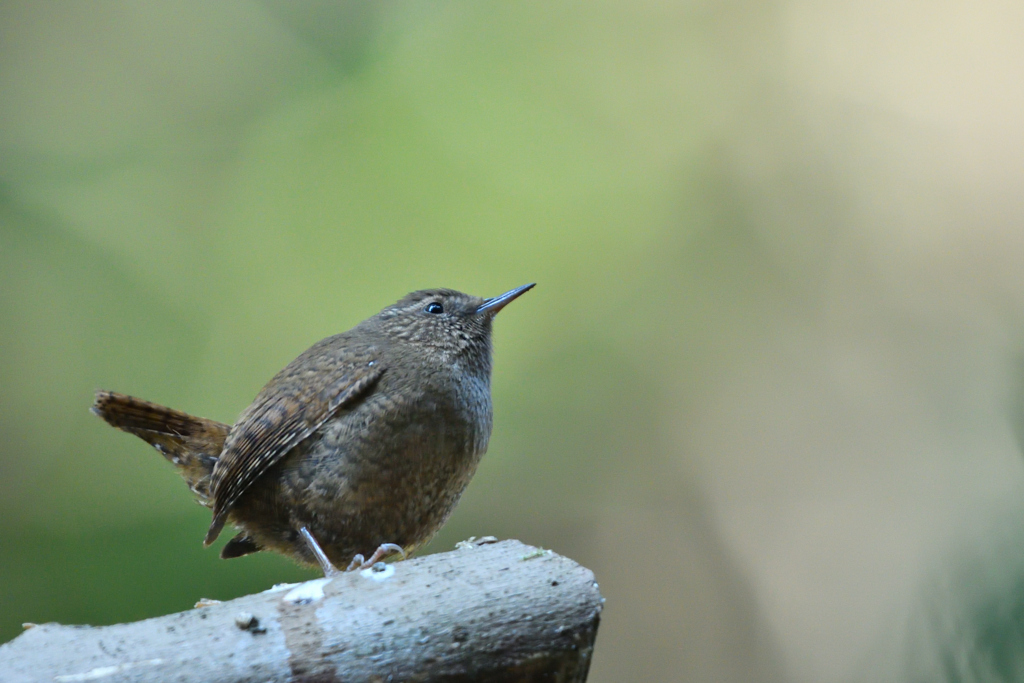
[92,285,534,575]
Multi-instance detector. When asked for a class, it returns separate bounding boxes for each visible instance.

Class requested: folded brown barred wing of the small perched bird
[205,348,384,545]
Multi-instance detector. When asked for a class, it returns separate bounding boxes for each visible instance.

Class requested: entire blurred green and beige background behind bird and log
[0,0,1024,683]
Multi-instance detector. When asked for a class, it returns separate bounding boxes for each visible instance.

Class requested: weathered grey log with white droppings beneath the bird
[0,541,603,683]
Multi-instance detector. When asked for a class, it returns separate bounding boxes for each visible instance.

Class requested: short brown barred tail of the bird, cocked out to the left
[92,390,230,507]
